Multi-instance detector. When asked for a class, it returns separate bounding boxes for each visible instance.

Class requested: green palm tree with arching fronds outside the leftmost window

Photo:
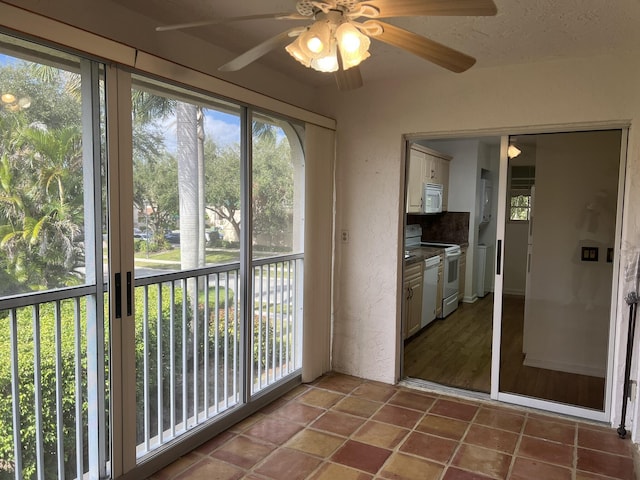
[0,122,84,288]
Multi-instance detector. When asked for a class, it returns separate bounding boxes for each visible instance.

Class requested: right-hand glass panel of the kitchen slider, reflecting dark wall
[500,131,621,410]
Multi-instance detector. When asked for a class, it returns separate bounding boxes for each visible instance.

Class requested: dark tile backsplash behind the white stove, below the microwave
[407,212,470,245]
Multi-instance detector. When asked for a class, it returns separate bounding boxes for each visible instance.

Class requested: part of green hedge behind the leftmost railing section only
[0,300,94,479]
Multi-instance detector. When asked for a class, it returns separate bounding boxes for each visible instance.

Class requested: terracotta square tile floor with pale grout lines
[151,374,635,480]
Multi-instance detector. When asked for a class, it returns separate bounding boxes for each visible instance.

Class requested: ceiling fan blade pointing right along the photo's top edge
[354,0,498,18]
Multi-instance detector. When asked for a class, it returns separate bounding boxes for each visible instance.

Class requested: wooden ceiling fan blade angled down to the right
[365,20,476,73]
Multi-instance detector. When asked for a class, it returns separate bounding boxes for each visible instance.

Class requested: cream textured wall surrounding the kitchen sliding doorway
[319,55,640,436]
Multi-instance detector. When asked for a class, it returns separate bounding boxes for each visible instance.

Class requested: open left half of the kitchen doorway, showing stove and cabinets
[399,137,500,393]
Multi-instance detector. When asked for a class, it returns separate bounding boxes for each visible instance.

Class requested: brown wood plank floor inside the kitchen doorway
[404,295,604,410]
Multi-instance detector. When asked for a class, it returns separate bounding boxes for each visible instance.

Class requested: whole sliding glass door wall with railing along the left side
[0,31,305,480]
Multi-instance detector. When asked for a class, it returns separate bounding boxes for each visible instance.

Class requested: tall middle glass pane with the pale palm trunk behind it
[132,77,242,458]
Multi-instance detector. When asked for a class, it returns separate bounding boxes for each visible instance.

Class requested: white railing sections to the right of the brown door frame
[135,255,303,458]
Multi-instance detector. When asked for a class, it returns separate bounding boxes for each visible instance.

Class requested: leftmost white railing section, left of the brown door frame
[0,287,108,480]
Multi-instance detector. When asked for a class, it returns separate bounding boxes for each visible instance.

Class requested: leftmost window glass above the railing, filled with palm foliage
[0,41,86,297]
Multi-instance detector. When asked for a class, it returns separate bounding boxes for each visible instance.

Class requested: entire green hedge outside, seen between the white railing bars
[0,286,280,480]
